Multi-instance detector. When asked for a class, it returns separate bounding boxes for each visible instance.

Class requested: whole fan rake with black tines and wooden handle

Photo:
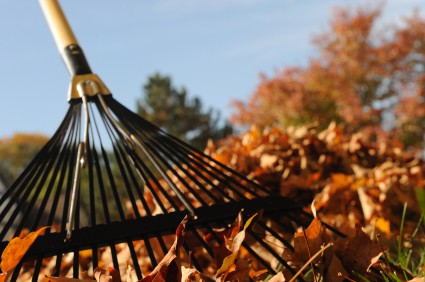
[0,0,342,281]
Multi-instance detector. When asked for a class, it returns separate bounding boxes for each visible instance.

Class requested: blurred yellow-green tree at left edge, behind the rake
[0,133,48,179]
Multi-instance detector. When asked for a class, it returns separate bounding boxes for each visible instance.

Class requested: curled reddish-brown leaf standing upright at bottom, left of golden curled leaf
[140,216,188,282]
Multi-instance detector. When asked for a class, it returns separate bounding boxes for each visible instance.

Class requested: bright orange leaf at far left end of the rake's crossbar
[0,227,49,272]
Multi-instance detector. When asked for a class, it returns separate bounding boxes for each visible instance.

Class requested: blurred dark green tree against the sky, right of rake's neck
[137,73,232,149]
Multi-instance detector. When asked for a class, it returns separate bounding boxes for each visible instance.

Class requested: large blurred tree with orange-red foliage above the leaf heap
[232,3,425,150]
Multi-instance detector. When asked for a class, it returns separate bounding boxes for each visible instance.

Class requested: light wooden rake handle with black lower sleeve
[39,0,92,77]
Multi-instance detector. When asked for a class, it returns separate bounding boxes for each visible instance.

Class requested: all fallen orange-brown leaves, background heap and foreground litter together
[0,124,425,282]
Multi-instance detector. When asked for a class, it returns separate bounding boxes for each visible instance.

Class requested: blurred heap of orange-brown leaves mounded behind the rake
[206,123,425,233]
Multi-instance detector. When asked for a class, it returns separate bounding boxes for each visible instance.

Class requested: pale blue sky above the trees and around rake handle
[0,0,425,138]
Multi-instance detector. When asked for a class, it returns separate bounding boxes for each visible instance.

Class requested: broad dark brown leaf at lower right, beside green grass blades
[335,228,382,274]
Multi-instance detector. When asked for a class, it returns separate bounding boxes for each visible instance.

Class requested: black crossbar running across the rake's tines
[0,196,300,260]
